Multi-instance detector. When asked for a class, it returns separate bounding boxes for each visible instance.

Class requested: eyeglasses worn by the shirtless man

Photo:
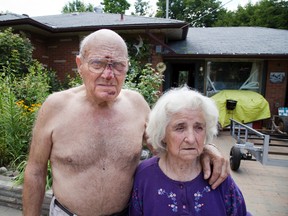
[81,56,129,76]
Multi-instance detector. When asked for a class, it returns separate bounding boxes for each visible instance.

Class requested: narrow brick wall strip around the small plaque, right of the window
[265,60,288,115]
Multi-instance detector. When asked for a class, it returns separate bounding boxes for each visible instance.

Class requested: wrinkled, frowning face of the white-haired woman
[163,109,206,160]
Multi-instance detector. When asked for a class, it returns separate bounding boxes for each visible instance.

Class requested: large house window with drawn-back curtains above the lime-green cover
[206,61,262,96]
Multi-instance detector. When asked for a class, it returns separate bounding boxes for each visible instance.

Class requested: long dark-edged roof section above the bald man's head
[0,12,188,40]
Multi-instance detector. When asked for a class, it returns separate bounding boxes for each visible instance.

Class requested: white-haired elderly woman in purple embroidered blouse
[129,87,250,216]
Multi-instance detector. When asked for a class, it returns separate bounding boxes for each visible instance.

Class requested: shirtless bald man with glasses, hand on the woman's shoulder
[23,30,229,216]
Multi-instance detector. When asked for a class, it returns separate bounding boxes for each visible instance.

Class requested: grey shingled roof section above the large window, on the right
[168,27,288,57]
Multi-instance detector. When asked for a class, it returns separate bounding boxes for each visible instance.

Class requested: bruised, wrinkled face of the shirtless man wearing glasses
[76,34,128,103]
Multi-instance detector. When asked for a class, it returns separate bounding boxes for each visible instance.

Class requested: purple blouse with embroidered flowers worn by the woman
[129,157,250,216]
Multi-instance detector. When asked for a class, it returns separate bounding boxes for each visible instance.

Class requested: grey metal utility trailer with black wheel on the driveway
[230,117,288,171]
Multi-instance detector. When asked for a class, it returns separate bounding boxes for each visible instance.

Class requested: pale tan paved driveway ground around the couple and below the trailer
[0,131,288,216]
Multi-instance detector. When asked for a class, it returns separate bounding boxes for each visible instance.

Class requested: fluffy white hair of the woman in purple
[146,86,219,153]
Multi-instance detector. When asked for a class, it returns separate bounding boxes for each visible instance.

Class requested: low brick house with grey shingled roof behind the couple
[0,12,288,120]
